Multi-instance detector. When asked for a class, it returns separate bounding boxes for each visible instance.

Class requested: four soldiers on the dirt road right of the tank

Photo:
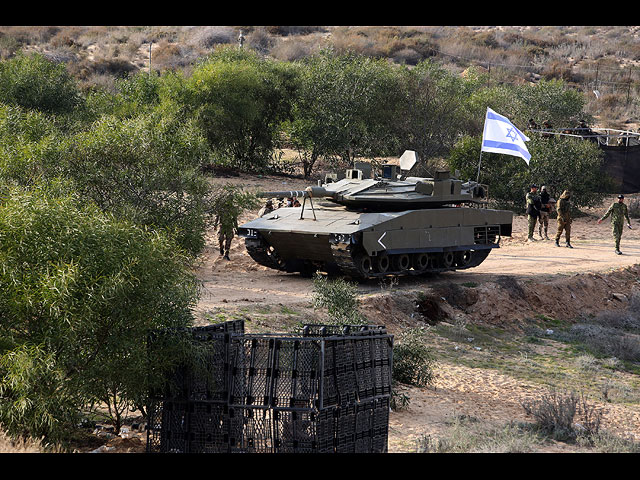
[526,184,631,255]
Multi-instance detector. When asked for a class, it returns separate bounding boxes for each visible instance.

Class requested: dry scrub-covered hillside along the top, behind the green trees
[0,26,640,130]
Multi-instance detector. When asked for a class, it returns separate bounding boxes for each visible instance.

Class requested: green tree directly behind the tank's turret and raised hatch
[287,50,401,177]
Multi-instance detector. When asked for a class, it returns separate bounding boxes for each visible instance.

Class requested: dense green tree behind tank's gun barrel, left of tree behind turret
[181,48,296,171]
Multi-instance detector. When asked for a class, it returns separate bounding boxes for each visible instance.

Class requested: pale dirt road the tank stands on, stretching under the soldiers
[198,207,640,313]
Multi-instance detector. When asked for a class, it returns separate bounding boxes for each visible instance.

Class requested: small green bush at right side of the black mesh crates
[393,329,435,387]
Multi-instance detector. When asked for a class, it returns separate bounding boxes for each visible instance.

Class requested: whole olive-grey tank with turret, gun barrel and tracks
[238,150,513,279]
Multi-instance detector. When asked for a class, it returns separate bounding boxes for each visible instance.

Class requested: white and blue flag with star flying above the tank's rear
[481,107,531,165]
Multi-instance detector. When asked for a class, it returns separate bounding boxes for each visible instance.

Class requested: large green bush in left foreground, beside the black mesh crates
[0,185,198,439]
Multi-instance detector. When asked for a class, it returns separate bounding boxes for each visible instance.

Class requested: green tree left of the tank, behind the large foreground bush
[60,114,210,254]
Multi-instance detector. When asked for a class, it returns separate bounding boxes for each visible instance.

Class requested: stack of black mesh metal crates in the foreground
[147,321,393,453]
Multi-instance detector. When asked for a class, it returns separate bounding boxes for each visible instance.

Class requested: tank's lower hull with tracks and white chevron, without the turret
[239,201,512,278]
